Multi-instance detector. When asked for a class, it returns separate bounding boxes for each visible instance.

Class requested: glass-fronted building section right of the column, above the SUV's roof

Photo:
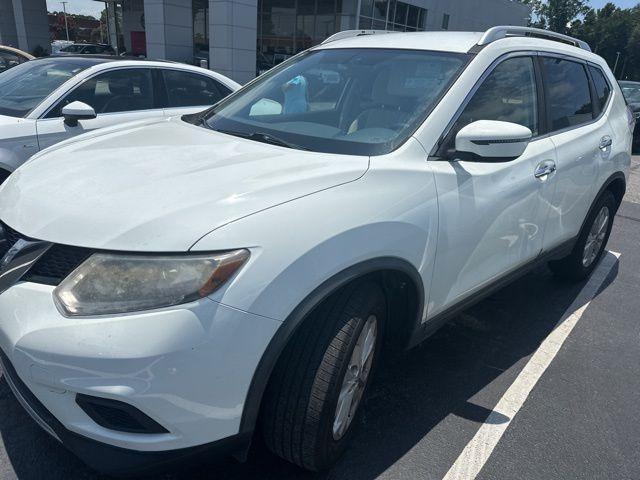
[257,0,530,71]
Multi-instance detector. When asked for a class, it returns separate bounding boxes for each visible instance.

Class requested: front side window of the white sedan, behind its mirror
[47,68,154,118]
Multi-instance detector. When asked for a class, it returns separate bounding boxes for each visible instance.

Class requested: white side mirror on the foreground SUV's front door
[456,120,533,162]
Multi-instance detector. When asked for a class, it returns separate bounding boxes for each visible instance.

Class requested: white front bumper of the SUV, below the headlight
[0,282,280,472]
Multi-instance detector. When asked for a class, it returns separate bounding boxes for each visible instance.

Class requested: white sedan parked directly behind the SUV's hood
[0,57,240,181]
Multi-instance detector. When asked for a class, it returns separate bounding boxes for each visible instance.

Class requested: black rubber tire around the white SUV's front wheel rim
[261,281,386,471]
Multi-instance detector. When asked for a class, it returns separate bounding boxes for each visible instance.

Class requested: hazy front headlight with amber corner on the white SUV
[53,250,249,315]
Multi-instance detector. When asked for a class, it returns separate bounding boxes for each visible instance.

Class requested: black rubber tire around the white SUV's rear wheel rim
[549,190,617,281]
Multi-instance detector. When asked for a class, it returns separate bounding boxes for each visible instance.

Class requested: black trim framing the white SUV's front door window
[428,50,547,162]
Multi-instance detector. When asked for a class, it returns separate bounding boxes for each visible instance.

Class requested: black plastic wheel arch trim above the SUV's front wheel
[239,257,424,444]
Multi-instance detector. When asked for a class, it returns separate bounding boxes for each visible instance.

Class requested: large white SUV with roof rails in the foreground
[0,27,633,473]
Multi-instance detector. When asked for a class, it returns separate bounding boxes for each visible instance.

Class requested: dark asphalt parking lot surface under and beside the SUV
[0,156,640,480]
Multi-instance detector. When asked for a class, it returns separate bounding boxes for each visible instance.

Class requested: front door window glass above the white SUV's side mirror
[454,57,538,136]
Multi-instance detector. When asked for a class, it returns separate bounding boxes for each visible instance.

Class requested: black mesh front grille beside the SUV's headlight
[0,222,94,286]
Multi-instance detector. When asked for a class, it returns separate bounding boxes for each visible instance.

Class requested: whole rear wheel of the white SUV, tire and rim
[549,190,616,280]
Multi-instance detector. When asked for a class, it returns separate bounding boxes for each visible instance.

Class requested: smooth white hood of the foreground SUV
[0,118,369,252]
